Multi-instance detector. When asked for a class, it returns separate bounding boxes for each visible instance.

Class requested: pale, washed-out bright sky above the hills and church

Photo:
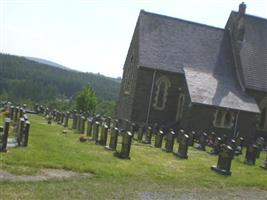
[0,0,267,78]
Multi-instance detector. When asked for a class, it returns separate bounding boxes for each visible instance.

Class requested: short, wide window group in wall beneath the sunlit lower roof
[213,110,235,128]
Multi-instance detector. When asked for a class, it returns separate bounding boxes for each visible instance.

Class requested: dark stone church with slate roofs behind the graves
[117,3,267,139]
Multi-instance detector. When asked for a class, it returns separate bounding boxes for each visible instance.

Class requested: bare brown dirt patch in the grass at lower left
[0,169,92,182]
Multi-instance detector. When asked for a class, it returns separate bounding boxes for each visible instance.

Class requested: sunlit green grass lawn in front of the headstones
[0,115,267,199]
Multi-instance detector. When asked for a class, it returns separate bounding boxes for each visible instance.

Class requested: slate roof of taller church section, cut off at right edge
[232,12,267,92]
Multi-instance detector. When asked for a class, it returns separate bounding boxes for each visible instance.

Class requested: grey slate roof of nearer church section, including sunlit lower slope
[138,11,259,113]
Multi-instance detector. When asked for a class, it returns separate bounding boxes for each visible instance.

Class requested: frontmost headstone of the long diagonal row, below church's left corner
[114,131,133,159]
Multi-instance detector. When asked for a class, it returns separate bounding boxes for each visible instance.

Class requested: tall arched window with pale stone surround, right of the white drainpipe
[153,76,171,110]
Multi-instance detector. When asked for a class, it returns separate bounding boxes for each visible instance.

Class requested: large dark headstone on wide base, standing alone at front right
[211,144,234,176]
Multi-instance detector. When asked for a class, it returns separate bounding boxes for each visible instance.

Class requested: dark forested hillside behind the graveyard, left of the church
[0,53,120,102]
